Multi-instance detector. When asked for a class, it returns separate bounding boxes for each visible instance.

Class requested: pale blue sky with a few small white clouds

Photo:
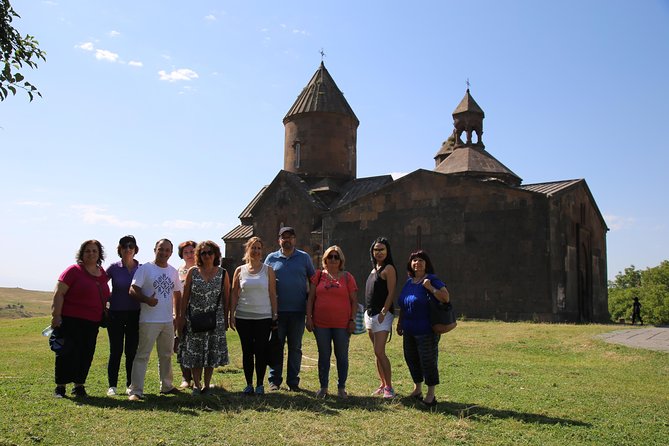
[0,0,669,290]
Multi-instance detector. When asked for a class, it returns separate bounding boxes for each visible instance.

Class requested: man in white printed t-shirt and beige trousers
[129,239,183,401]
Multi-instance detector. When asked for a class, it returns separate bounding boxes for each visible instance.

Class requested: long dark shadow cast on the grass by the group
[57,388,591,427]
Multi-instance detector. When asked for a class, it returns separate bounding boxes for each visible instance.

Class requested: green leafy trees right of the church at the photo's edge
[609,260,669,325]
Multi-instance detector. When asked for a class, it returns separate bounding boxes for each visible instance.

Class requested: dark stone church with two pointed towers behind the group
[223,63,609,322]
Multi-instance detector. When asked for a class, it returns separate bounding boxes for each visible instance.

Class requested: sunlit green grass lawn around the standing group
[0,317,669,445]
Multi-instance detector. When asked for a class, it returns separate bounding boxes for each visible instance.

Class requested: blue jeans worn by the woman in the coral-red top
[314,327,351,389]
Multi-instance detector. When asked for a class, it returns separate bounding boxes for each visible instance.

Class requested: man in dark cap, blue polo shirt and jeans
[265,226,315,391]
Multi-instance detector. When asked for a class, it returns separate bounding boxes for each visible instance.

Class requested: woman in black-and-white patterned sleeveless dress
[179,240,230,395]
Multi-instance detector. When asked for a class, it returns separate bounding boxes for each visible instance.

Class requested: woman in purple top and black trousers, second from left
[107,235,139,396]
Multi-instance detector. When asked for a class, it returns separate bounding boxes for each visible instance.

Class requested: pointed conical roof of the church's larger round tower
[283,62,359,123]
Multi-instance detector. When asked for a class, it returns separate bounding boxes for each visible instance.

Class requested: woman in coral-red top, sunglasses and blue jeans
[307,246,358,398]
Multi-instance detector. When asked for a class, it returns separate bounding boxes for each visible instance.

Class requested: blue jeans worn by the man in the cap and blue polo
[268,311,305,387]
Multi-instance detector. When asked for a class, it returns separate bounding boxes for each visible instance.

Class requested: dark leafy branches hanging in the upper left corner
[0,0,46,101]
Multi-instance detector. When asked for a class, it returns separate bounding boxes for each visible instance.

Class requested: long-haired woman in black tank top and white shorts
[365,237,397,398]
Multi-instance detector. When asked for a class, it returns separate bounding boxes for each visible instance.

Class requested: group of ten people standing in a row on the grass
[51,227,450,407]
